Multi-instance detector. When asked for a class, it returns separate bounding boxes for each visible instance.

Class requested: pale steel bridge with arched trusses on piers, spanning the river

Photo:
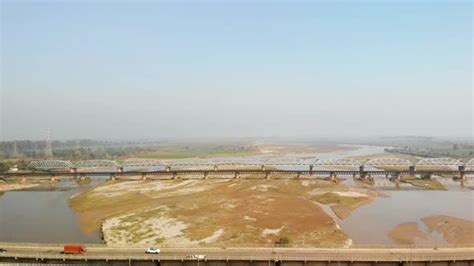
[0,158,474,180]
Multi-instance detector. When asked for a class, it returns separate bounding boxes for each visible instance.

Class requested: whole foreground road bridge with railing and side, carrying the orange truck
[0,243,474,266]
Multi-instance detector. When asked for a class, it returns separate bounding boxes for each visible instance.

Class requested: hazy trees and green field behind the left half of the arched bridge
[0,140,255,161]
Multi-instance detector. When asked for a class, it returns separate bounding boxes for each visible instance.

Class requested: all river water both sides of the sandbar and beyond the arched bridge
[0,146,474,245]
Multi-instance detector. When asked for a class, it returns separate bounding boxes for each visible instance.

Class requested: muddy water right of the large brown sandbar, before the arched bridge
[334,190,474,245]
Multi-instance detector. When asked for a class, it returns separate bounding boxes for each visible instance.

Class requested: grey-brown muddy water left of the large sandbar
[0,179,101,243]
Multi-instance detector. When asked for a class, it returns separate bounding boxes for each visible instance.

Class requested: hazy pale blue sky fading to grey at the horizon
[0,0,473,140]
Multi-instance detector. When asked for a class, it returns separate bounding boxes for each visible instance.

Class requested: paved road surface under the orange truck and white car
[0,243,474,262]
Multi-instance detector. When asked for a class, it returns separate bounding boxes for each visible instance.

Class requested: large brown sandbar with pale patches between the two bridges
[70,179,370,246]
